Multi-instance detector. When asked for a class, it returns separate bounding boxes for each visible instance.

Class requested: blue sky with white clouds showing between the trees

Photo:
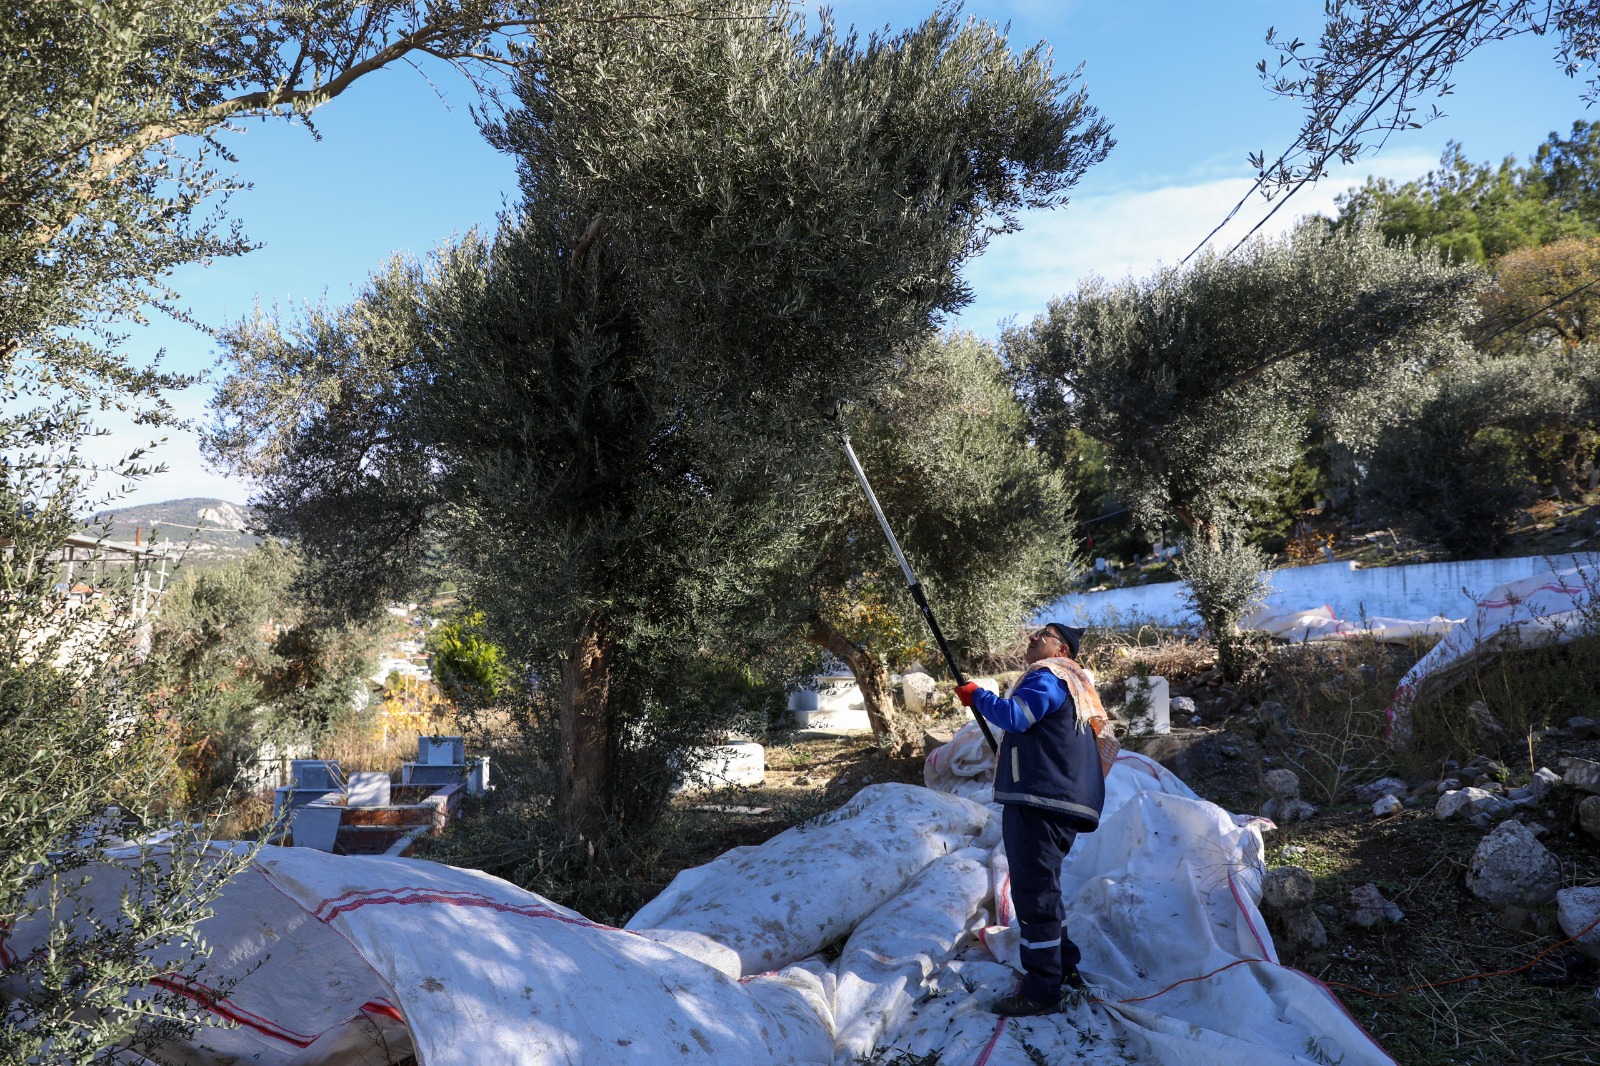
[107,0,1590,503]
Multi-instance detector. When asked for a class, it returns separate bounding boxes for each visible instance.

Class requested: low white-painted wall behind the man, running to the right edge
[1037,552,1600,626]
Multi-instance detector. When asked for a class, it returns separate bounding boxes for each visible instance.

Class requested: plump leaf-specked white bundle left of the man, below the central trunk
[627,783,989,973]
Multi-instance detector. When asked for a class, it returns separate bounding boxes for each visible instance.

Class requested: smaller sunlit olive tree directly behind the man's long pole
[796,333,1080,746]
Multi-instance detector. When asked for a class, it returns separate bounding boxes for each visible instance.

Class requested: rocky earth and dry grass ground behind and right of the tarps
[638,630,1600,1066]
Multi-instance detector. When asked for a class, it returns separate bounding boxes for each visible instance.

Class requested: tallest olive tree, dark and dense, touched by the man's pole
[218,3,1109,839]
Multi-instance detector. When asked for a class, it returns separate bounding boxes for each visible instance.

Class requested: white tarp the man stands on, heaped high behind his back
[885,741,1392,1066]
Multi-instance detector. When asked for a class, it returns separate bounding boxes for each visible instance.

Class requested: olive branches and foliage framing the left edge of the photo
[0,0,601,1043]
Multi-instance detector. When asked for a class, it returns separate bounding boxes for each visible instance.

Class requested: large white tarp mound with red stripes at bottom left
[6,847,834,1066]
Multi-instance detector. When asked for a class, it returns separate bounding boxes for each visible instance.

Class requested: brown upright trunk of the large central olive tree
[555,618,614,842]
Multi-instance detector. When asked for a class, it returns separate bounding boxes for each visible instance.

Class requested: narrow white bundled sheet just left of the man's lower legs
[834,848,989,1066]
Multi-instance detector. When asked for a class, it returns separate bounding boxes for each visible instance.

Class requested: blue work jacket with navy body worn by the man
[973,669,1106,832]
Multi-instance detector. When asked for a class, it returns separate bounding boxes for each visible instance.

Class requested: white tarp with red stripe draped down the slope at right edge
[1389,563,1600,744]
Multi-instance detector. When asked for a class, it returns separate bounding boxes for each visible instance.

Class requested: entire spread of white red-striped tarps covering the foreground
[18,736,1390,1066]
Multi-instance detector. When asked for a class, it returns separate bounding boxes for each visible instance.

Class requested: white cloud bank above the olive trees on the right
[960,155,1435,336]
